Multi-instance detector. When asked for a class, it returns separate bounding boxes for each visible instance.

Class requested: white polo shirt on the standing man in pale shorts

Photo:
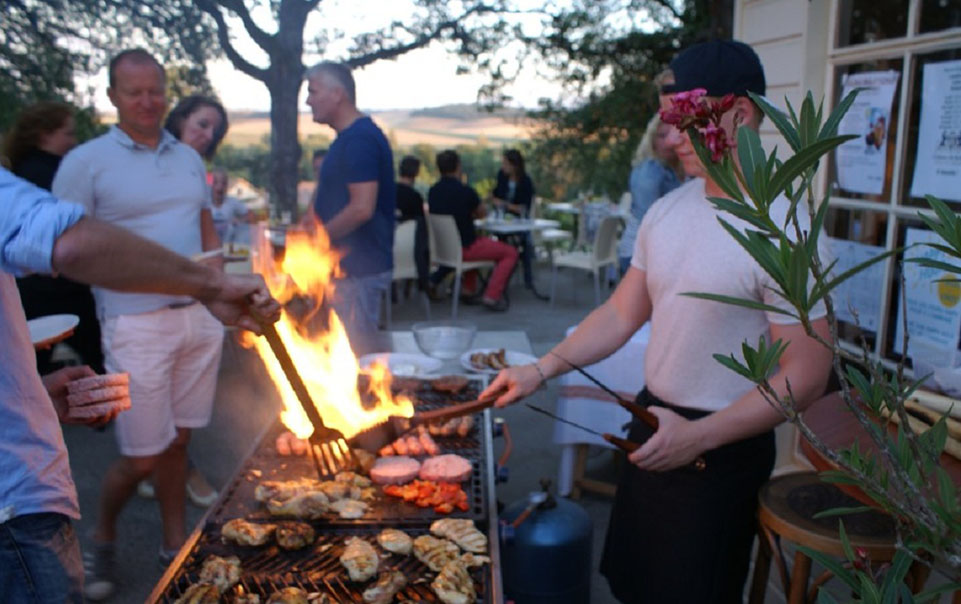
[53,126,208,319]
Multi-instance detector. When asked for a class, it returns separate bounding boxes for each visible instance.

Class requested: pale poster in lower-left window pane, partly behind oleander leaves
[827,237,886,333]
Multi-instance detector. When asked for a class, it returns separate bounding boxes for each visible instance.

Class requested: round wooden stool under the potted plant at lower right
[748,472,927,604]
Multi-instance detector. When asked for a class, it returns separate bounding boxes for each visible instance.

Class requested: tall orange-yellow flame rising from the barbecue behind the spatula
[244,225,414,438]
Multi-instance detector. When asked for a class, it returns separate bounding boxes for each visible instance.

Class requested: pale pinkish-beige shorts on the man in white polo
[101,304,224,457]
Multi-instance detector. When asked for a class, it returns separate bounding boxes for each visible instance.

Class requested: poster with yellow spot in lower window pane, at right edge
[893,228,961,358]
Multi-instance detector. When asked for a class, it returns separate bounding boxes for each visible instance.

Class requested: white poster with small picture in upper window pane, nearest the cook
[836,71,901,195]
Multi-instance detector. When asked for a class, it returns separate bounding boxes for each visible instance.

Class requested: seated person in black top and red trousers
[427,149,518,311]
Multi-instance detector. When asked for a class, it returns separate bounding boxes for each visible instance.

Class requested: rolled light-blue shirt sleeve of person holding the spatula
[0,168,84,276]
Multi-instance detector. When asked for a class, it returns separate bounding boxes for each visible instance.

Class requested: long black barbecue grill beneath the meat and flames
[147,381,503,603]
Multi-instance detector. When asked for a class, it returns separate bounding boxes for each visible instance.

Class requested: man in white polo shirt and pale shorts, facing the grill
[53,49,223,599]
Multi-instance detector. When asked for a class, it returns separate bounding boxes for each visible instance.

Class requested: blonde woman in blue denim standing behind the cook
[617,112,681,275]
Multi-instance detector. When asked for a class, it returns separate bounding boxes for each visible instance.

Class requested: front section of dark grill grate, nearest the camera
[160,528,491,603]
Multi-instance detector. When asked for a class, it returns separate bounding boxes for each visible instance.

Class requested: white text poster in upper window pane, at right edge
[911,61,961,201]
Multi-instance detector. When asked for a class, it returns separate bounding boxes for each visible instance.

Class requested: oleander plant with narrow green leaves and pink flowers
[661,90,961,603]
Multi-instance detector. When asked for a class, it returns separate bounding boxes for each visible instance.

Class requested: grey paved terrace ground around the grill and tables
[64,268,783,604]
